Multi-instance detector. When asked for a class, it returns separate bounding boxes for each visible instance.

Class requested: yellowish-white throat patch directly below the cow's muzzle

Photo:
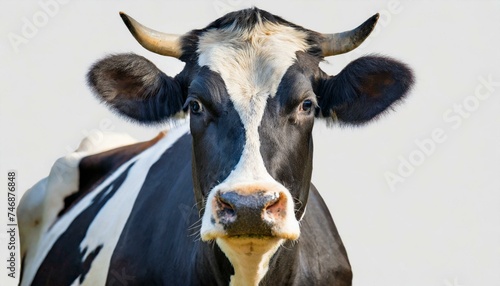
[217,238,283,286]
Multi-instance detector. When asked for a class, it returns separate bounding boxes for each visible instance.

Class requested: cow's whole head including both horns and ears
[88,8,413,284]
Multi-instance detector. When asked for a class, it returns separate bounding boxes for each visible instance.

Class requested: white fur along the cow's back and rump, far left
[17,133,142,257]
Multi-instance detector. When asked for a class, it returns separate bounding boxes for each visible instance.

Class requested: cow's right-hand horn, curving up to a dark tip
[321,13,379,57]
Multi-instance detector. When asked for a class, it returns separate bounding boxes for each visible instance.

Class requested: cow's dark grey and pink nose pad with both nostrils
[215,191,286,236]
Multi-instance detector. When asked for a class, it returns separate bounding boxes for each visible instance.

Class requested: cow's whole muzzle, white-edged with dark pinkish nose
[201,182,300,240]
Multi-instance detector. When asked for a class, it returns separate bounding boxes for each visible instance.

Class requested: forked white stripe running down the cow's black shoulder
[21,124,189,285]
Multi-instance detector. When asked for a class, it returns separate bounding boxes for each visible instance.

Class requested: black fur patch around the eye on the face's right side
[259,52,319,219]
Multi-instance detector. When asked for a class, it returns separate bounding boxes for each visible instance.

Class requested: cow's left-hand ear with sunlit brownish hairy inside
[87,54,184,124]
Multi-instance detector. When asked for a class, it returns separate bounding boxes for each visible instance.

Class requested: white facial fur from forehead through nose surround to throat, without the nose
[198,12,309,285]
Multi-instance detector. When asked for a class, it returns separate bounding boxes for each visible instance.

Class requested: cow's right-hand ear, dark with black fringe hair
[318,56,414,125]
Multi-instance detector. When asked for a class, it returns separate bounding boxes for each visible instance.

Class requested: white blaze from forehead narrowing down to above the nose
[198,17,309,181]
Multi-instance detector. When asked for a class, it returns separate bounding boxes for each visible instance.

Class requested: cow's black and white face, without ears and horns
[187,18,317,240]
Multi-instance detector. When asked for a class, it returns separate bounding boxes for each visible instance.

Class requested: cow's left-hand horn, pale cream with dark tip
[120,12,182,58]
